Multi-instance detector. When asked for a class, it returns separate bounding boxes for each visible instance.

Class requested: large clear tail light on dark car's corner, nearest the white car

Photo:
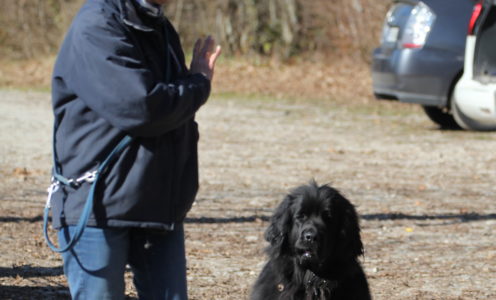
[401,2,436,48]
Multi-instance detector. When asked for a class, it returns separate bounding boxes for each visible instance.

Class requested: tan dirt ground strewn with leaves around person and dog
[0,90,496,300]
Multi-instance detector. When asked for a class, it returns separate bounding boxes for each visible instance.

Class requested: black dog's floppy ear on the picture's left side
[265,195,293,256]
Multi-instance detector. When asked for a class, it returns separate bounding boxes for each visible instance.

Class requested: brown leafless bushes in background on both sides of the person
[0,0,389,59]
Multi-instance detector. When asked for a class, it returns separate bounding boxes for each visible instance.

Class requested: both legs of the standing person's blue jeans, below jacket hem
[58,224,188,300]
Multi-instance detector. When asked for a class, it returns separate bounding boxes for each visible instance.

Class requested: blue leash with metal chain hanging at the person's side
[43,130,133,253]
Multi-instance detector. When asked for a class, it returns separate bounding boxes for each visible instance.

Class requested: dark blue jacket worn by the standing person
[52,0,210,229]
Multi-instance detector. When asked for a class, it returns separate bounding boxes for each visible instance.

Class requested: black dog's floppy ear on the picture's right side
[334,193,363,258]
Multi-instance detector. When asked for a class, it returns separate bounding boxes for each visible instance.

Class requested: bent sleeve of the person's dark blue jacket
[63,15,210,136]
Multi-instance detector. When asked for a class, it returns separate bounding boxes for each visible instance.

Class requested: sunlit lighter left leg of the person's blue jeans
[58,226,129,300]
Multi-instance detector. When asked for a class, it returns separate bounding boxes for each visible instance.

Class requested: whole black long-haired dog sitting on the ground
[251,182,371,300]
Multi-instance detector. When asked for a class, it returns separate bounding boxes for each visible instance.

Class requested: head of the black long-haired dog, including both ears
[265,182,363,272]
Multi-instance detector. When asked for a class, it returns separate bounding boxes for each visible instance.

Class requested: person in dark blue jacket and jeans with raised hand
[50,0,221,300]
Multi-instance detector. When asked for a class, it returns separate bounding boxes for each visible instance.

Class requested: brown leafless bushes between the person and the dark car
[167,0,390,59]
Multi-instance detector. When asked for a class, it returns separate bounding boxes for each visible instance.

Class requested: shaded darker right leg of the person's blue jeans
[129,224,188,300]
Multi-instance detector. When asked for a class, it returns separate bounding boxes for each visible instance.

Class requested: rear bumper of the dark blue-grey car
[372,48,463,106]
